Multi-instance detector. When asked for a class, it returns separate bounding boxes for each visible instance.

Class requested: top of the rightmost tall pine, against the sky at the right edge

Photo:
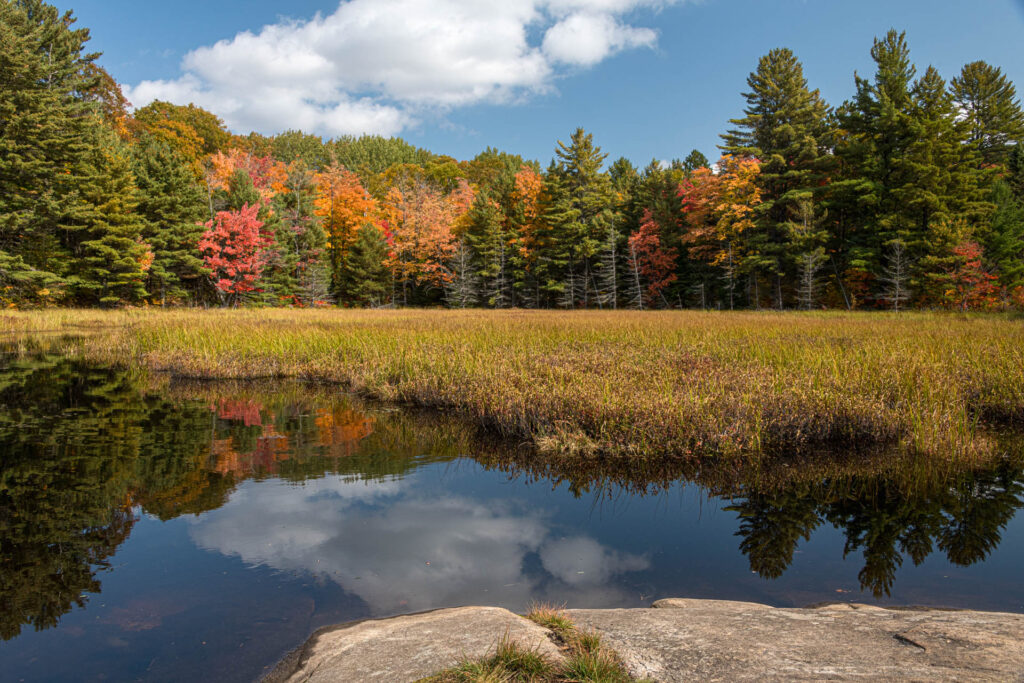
[950,61,1024,167]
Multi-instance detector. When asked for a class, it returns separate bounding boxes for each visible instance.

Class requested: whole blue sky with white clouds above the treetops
[61,0,1024,165]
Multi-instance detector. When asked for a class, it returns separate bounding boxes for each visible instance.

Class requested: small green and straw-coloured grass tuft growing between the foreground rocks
[420,605,634,683]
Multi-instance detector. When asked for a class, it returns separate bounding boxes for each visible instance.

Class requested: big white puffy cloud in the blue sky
[125,0,683,135]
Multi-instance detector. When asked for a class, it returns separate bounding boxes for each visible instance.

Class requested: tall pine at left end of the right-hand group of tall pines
[721,48,830,307]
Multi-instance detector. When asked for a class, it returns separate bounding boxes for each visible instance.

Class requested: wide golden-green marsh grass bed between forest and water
[0,309,1024,460]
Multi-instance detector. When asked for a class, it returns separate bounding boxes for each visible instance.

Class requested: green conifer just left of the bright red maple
[133,137,207,305]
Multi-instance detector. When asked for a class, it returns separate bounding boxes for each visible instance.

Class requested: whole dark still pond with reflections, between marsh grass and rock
[0,358,1024,681]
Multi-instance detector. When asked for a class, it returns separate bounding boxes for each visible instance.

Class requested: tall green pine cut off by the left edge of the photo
[0,0,101,273]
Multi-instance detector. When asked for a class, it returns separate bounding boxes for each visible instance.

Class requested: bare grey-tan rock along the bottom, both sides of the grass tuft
[266,599,1024,683]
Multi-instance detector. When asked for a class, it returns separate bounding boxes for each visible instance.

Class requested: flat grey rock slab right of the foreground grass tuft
[568,599,1024,682]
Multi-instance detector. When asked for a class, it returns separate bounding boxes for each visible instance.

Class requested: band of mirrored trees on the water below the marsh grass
[0,355,1024,640]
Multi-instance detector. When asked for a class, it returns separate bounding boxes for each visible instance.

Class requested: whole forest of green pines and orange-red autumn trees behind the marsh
[0,0,1024,310]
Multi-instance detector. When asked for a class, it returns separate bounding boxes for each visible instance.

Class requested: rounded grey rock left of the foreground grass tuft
[264,607,561,683]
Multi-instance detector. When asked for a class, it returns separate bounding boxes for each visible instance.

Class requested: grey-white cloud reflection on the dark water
[189,476,648,614]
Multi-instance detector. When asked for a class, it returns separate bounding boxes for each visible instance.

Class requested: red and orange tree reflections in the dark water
[210,399,374,478]
